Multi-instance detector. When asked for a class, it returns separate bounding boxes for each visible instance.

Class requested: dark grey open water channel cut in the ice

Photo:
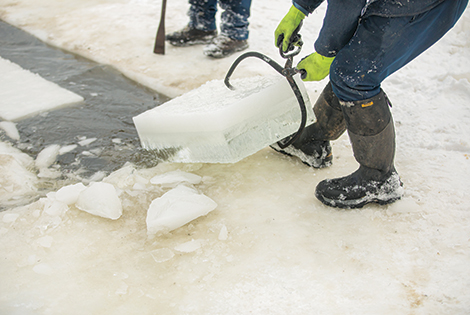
[0,21,169,177]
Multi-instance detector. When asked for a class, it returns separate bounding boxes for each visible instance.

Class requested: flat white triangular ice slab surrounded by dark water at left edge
[0,58,83,121]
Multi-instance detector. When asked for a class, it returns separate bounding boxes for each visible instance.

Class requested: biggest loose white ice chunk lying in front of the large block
[147,185,217,234]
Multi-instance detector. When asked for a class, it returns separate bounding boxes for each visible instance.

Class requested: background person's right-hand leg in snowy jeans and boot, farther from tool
[203,0,251,58]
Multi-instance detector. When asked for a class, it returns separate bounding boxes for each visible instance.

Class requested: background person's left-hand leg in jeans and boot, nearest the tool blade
[166,0,217,46]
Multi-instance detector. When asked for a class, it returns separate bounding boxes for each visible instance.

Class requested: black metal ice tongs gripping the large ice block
[224,22,307,149]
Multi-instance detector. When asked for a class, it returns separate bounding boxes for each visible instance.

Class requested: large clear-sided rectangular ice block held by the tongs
[133,75,315,163]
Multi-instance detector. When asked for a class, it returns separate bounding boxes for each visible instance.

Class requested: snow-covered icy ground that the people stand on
[0,0,470,314]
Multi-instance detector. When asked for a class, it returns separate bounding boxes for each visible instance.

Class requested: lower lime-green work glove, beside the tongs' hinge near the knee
[297,52,335,81]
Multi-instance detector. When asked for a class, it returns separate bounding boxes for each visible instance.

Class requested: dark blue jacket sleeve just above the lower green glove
[312,0,367,57]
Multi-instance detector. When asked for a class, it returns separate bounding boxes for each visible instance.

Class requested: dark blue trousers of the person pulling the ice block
[330,0,468,101]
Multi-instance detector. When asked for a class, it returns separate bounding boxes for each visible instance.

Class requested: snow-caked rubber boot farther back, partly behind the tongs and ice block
[271,83,346,168]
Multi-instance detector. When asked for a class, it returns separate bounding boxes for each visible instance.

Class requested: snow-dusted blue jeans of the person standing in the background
[188,0,251,40]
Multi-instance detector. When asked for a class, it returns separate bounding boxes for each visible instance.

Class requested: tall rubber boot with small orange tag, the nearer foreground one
[315,91,404,208]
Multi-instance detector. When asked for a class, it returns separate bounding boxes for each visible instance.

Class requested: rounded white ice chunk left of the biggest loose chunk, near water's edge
[76,182,122,220]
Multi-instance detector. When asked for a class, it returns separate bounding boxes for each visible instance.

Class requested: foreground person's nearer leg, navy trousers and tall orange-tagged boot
[315,0,468,208]
